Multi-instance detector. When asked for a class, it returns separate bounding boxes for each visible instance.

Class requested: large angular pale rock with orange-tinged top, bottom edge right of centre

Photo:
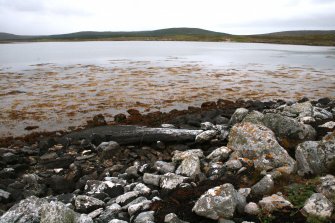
[192,184,237,220]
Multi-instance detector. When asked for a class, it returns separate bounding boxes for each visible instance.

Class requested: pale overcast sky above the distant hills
[0,0,335,35]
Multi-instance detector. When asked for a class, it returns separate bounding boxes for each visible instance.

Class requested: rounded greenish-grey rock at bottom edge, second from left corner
[40,201,77,223]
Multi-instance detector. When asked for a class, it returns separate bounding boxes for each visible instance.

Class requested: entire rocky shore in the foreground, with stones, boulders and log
[0,98,335,223]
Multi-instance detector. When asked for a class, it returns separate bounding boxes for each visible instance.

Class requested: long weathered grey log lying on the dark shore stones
[56,125,202,145]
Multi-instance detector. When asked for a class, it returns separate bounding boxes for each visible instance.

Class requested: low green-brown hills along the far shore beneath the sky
[0,28,335,46]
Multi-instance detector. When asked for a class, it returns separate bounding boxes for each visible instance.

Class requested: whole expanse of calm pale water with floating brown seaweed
[0,41,335,136]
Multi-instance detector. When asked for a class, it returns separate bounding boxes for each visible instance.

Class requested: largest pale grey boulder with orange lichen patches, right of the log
[227,122,295,174]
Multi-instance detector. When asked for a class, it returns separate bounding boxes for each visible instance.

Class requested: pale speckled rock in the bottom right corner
[301,193,334,218]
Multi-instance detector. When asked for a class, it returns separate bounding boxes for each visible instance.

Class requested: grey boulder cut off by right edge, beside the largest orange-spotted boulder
[295,132,335,176]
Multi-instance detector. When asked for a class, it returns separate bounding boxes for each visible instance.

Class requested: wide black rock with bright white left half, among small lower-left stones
[85,180,124,198]
